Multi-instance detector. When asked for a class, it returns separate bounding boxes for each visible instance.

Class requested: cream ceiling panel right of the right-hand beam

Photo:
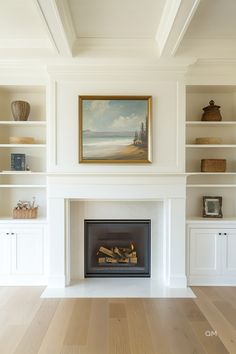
[177,0,236,58]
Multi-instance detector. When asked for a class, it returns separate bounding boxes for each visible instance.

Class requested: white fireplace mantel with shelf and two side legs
[48,174,187,288]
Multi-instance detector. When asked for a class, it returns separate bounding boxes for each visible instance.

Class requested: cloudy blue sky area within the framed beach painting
[83,100,148,132]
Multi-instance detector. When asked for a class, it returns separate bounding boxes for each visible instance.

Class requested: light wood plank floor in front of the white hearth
[0,287,236,354]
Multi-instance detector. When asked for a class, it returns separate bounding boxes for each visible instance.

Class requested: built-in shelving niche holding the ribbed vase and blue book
[0,85,47,219]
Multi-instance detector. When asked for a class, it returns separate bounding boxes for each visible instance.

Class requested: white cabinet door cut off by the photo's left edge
[0,229,12,275]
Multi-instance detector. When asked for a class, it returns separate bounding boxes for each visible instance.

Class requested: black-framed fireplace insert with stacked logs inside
[84,219,151,278]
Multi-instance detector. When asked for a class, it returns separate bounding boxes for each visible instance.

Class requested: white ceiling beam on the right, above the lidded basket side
[156,0,200,56]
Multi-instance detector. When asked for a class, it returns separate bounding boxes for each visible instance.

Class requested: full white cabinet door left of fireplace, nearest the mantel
[12,227,43,274]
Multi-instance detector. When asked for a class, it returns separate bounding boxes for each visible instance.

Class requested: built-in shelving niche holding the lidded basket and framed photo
[185,85,236,220]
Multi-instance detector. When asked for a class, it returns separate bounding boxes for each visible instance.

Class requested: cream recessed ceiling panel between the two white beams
[68,0,166,38]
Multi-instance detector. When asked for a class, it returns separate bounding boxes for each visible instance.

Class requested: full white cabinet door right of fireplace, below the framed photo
[189,229,221,275]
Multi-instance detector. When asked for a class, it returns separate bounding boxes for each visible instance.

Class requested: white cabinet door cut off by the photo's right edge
[222,229,236,276]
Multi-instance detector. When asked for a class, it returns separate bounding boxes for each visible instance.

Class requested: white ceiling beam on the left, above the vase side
[35,0,76,57]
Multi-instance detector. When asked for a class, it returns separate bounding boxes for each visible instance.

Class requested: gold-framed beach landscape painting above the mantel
[79,96,152,163]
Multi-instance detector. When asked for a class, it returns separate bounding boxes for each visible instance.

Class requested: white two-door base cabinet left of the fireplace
[0,223,47,285]
